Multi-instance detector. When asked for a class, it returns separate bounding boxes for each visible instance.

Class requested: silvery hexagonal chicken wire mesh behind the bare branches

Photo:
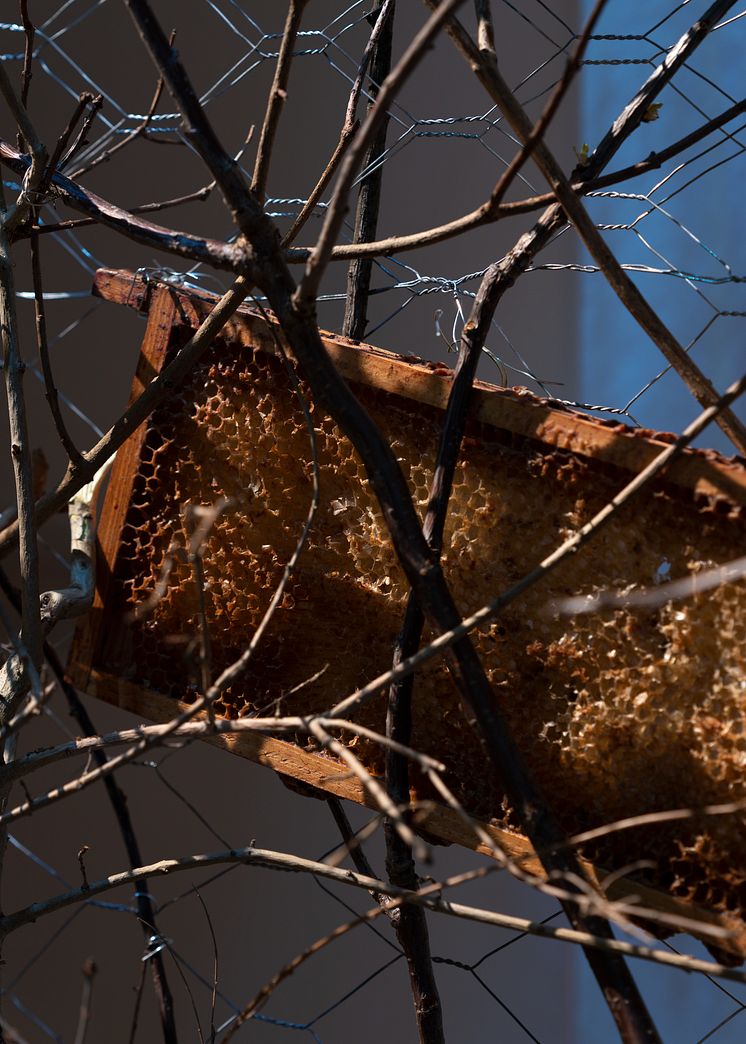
[0,0,746,1044]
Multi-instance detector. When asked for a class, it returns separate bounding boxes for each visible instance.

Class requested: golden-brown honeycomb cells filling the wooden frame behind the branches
[78,288,746,947]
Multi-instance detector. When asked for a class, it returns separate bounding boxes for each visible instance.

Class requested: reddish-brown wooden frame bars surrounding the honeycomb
[70,270,746,953]
